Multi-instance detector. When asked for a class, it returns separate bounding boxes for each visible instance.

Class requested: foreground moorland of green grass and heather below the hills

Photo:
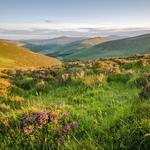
[0,55,150,150]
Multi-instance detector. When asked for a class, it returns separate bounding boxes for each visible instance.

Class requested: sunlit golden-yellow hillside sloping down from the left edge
[0,40,61,67]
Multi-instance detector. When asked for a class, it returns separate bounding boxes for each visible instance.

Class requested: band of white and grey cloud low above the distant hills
[0,19,150,39]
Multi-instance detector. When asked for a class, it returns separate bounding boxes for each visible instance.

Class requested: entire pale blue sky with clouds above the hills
[0,0,150,39]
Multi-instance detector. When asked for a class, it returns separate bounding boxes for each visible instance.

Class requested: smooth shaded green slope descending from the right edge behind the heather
[63,34,150,60]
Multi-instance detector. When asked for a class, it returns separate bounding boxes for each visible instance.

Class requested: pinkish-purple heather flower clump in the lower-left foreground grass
[21,110,78,142]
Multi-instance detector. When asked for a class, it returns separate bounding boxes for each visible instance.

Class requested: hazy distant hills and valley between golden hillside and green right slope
[21,37,111,60]
